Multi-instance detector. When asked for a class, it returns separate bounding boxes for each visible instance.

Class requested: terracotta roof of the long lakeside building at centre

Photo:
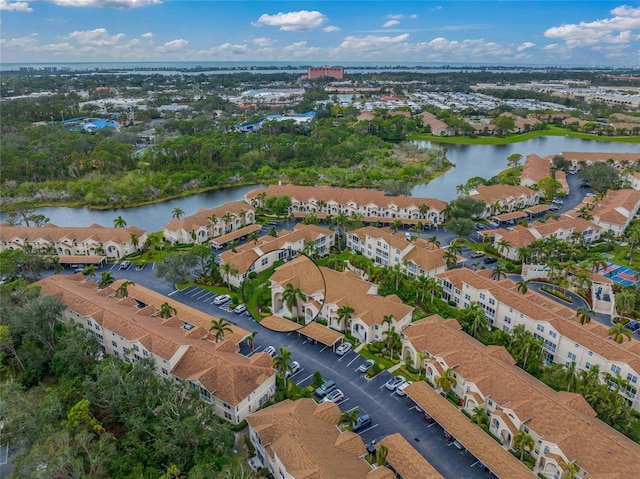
[246,185,447,211]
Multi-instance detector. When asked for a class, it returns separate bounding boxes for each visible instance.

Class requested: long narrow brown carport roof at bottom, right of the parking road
[404,381,537,479]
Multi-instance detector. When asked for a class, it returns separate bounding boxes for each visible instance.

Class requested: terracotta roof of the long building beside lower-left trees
[36,275,275,405]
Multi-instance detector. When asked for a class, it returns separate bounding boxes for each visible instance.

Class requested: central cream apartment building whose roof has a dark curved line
[271,258,414,343]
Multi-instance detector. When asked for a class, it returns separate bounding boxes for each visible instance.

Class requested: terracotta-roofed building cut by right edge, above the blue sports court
[590,189,640,236]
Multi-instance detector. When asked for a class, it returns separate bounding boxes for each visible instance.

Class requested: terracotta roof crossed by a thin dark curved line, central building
[271,257,413,326]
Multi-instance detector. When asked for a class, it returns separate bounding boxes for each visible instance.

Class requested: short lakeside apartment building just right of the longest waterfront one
[469,185,540,218]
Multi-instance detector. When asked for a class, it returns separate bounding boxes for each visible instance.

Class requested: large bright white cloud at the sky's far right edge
[544,5,640,48]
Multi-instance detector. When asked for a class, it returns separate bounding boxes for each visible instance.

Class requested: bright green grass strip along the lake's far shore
[407,126,640,145]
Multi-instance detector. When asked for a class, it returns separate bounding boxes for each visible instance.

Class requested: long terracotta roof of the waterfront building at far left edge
[0,223,146,246]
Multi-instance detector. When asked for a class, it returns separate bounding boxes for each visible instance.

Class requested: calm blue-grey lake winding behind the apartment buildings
[0,136,640,231]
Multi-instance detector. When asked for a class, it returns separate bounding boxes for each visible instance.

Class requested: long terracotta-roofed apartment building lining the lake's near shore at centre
[245,185,447,225]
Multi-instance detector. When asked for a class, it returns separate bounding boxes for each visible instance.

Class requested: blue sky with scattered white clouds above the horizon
[0,0,640,66]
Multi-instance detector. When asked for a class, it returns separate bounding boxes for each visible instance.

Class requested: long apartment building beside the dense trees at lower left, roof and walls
[36,273,276,424]
